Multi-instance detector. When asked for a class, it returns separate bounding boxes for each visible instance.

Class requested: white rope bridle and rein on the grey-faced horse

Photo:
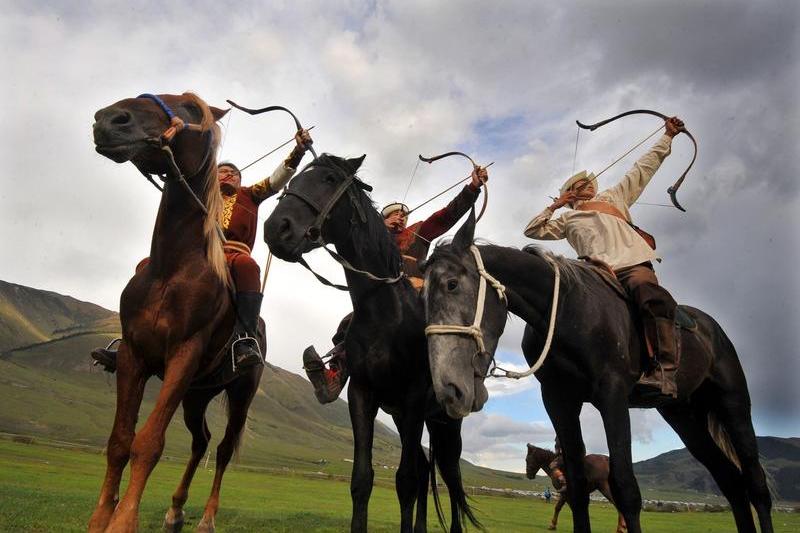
[425,244,561,379]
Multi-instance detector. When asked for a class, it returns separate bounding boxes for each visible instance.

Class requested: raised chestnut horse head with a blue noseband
[93,93,227,180]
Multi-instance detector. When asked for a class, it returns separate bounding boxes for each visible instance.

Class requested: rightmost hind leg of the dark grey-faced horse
[718,390,773,533]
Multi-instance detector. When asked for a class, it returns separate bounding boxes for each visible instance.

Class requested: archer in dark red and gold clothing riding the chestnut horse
[92,128,314,372]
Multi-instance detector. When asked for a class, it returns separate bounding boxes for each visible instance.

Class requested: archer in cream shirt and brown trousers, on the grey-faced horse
[525,117,684,396]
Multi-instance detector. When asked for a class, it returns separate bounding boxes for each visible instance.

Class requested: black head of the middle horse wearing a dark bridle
[264,154,377,262]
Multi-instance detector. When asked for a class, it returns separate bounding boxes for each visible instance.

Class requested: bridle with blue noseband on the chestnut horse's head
[136,93,226,242]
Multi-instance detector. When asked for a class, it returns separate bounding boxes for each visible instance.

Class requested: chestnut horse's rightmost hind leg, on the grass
[197,371,261,533]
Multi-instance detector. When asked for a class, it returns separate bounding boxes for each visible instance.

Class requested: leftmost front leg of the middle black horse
[347,380,378,532]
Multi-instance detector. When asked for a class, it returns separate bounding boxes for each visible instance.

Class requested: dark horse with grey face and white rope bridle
[425,210,773,533]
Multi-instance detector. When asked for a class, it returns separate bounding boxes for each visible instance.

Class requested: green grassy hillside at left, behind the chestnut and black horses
[0,281,531,489]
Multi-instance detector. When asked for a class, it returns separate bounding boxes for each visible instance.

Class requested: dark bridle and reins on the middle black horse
[278,164,405,291]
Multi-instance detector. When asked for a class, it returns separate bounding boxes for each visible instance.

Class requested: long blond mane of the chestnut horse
[183,92,231,287]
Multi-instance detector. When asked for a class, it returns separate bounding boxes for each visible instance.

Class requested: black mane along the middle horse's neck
[304,154,402,276]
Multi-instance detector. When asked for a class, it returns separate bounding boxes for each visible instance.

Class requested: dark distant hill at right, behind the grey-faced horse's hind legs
[633,437,800,502]
